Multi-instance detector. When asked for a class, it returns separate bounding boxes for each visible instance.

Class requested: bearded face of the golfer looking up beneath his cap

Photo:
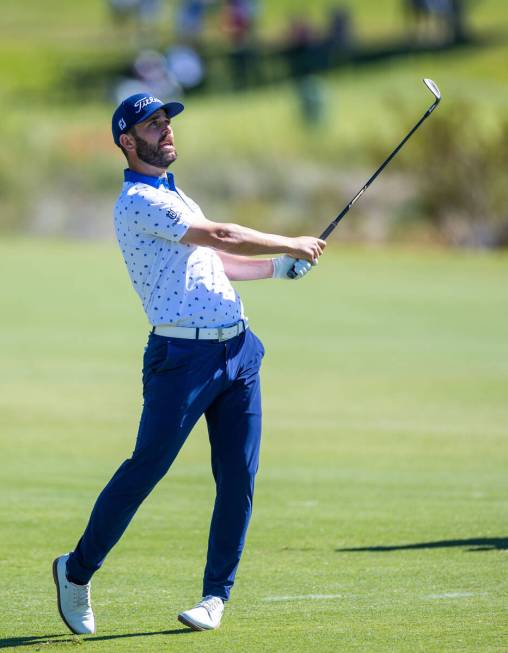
[131,109,177,168]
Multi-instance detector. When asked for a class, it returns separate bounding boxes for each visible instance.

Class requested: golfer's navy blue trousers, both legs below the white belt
[67,329,264,600]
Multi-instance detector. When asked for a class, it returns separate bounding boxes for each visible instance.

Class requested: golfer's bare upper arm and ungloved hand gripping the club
[180,220,326,262]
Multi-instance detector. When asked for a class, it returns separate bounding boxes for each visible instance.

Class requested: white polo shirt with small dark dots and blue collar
[114,170,244,327]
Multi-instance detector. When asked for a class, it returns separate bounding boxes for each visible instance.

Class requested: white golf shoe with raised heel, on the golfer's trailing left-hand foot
[53,553,95,635]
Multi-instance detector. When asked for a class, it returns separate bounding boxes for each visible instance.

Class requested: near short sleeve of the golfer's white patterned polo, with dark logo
[129,186,190,242]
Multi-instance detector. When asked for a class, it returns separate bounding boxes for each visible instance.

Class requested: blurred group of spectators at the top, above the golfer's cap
[108,0,353,104]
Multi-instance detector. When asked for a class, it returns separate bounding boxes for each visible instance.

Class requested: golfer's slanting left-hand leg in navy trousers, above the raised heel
[67,336,221,584]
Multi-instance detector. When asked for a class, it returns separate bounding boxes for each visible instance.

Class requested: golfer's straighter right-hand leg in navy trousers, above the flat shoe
[203,332,264,600]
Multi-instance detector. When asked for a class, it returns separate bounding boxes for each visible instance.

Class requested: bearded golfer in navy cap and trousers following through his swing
[53,93,325,634]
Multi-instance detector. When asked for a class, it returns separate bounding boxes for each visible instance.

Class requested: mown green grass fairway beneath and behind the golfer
[0,239,508,653]
